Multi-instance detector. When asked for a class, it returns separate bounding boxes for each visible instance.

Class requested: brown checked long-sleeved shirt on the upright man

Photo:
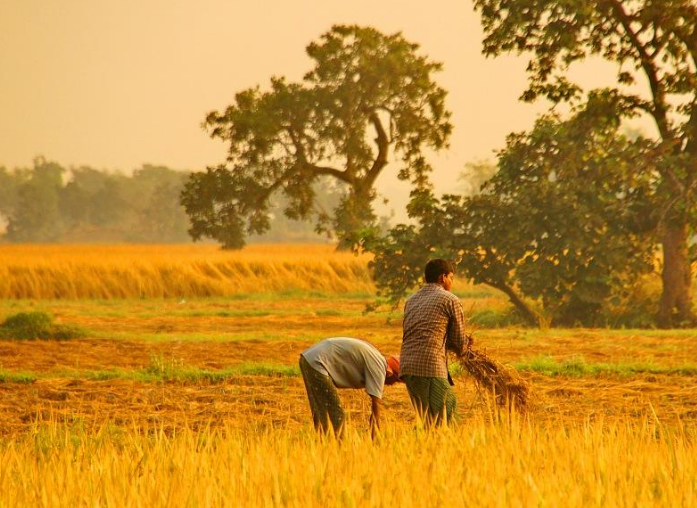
[399,284,468,378]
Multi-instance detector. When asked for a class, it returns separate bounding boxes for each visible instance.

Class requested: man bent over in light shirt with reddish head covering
[300,337,399,437]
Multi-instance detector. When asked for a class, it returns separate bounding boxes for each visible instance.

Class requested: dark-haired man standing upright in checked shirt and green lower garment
[400,259,470,426]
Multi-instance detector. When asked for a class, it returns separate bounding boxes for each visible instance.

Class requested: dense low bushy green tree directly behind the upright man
[366,106,654,326]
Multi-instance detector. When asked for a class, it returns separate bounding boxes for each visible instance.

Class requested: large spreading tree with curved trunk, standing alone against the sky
[182,26,452,248]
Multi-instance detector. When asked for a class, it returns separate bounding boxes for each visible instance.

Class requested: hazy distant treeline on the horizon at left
[0,157,333,243]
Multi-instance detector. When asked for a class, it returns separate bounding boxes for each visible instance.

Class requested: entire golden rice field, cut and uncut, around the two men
[0,246,697,508]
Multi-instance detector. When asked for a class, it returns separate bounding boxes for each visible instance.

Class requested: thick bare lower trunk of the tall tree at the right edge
[656,221,697,328]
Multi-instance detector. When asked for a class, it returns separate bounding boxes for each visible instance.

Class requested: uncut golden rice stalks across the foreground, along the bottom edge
[0,419,697,507]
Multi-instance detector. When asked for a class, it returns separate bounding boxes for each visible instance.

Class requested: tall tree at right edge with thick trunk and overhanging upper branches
[474,0,697,327]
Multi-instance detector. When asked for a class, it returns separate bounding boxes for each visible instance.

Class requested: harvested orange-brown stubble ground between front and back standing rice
[0,295,697,436]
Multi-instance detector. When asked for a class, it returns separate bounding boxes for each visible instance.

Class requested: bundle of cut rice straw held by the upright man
[458,347,530,413]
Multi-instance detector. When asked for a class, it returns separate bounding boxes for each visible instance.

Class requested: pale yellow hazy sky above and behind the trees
[0,0,640,212]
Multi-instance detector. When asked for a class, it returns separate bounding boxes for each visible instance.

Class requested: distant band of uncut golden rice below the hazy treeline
[0,245,375,299]
